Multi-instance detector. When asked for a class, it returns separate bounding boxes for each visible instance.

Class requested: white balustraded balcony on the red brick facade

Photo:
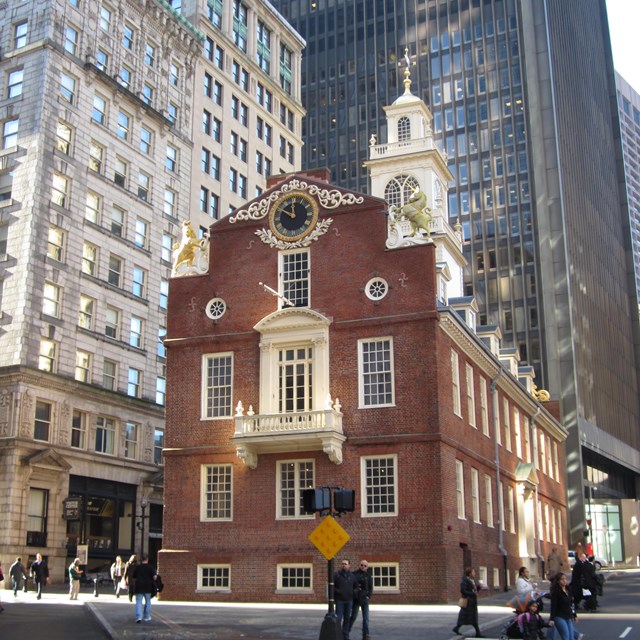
[231,400,346,469]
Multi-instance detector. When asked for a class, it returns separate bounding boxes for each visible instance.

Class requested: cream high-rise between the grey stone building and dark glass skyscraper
[172,0,304,230]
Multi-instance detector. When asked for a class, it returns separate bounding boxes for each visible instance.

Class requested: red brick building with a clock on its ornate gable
[159,72,566,603]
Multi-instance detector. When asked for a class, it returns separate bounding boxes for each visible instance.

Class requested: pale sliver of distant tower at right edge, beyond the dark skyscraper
[616,73,640,304]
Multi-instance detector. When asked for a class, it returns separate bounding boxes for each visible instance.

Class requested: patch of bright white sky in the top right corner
[607,0,640,93]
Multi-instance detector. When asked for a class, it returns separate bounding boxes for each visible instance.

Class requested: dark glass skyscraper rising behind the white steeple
[277,0,640,559]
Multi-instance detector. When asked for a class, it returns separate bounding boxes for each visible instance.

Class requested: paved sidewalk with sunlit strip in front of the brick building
[12,570,618,640]
